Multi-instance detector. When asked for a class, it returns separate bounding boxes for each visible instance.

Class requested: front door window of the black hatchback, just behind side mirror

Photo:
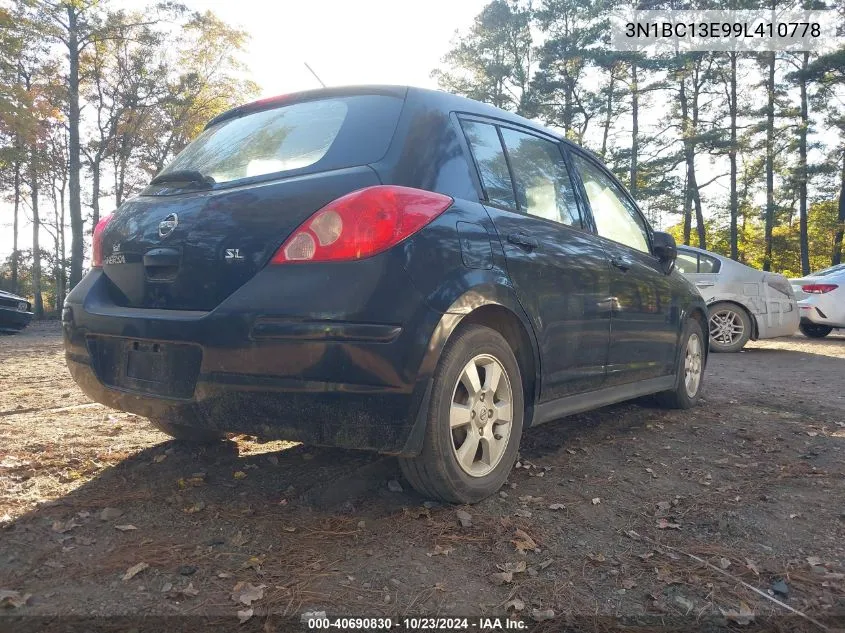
[574,154,649,253]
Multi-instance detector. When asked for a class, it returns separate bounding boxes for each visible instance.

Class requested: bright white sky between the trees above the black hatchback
[0,0,485,260]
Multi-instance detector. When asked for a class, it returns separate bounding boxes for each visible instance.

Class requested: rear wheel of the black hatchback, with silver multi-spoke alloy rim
[399,325,525,503]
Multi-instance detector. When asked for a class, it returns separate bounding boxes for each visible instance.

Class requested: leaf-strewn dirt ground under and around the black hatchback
[0,323,845,631]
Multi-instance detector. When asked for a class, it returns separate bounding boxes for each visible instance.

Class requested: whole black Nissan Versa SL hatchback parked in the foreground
[63,86,707,502]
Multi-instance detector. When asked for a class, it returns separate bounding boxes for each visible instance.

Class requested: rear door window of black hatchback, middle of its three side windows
[502,128,581,228]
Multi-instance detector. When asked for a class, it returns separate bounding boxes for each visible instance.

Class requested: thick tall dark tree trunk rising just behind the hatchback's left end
[67,4,85,287]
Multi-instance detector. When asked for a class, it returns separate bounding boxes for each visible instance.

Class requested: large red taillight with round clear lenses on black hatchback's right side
[270,185,452,264]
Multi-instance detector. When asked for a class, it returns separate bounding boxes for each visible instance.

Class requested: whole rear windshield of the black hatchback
[156,95,402,184]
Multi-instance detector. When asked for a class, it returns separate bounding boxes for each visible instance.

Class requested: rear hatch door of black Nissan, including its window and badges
[97,89,404,311]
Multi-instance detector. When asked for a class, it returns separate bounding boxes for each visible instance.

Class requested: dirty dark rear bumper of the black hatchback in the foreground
[62,271,442,453]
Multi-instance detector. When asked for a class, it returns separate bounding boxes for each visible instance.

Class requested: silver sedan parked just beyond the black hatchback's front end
[675,246,800,352]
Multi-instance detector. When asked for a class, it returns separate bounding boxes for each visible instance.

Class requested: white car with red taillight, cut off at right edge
[790,264,845,338]
